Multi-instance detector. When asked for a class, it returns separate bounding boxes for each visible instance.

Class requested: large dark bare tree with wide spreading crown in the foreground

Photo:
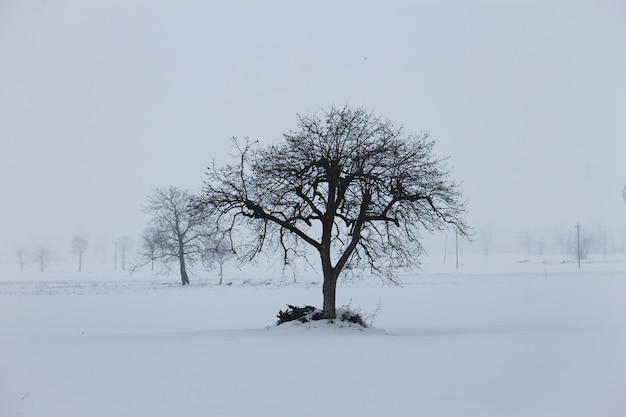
[196,107,469,319]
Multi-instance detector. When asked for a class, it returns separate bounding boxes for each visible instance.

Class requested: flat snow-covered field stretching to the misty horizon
[0,256,626,416]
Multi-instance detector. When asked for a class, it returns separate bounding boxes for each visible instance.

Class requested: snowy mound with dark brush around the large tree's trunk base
[267,304,386,334]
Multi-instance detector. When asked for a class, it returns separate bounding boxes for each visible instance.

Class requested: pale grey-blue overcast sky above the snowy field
[0,0,626,253]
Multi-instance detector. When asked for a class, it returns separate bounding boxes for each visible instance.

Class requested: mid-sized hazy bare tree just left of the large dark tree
[144,187,207,285]
